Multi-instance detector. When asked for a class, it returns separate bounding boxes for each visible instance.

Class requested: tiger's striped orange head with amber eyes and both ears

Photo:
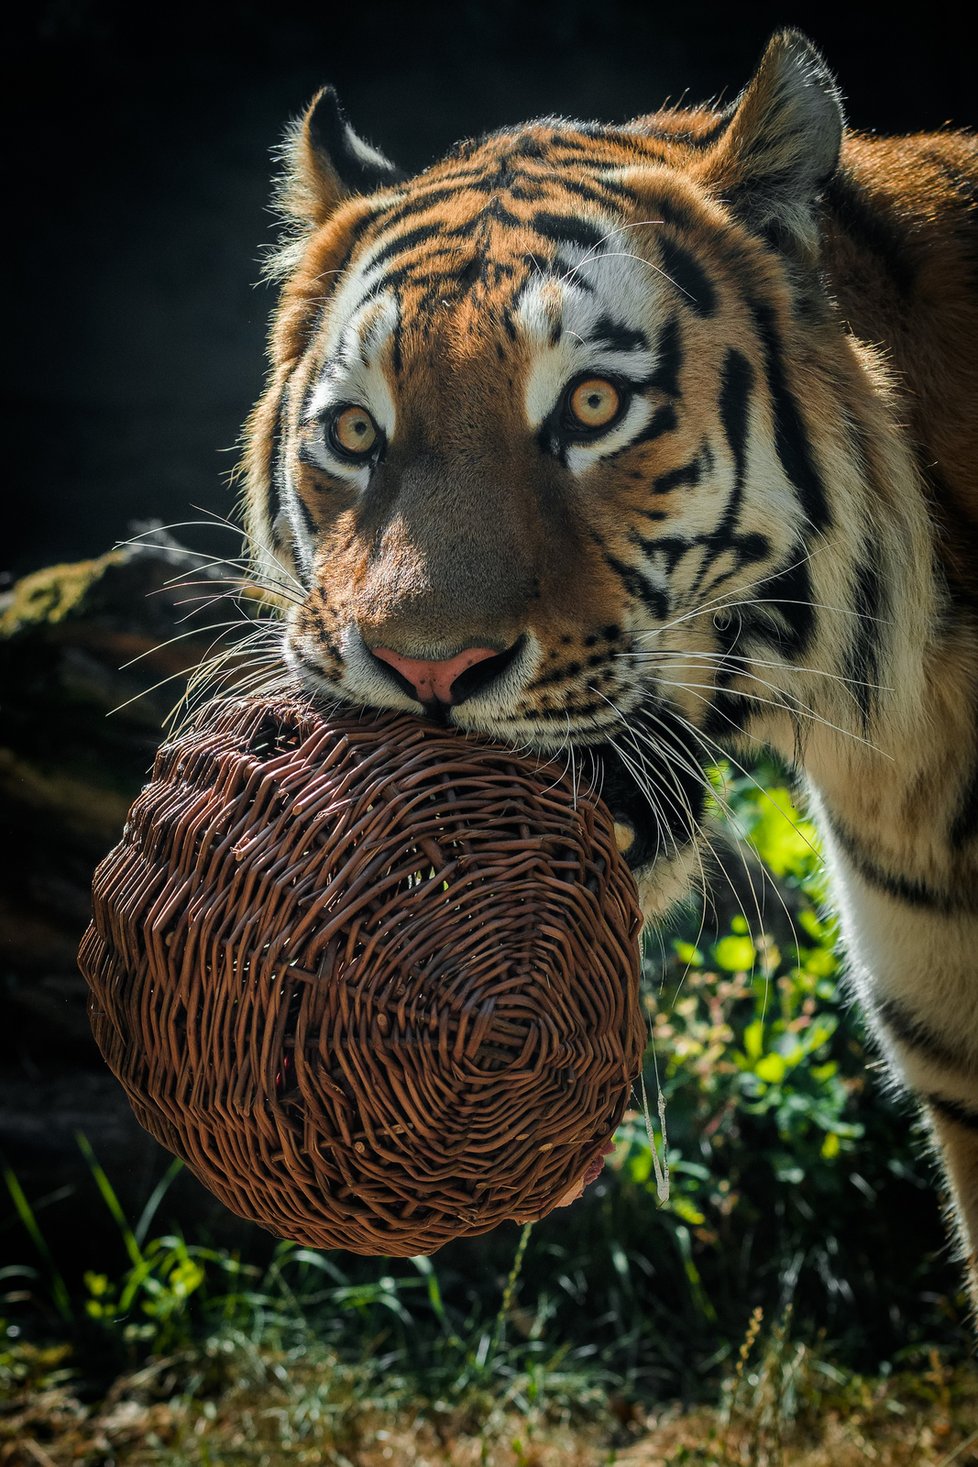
[246,32,843,903]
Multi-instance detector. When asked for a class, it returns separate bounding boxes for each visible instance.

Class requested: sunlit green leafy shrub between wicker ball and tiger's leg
[604,769,960,1366]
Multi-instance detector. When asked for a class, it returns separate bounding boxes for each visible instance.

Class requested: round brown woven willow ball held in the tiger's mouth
[79,700,645,1254]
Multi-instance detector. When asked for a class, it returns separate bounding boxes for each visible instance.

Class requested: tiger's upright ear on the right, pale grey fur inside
[705,31,845,254]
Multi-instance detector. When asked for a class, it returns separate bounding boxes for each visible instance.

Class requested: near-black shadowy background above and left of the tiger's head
[7,0,977,574]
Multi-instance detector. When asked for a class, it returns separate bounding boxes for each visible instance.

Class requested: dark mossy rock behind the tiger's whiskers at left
[0,535,268,998]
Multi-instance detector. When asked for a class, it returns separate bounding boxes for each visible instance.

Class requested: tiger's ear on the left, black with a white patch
[277,87,405,224]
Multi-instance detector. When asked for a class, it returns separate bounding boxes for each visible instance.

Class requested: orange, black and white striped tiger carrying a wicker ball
[242,31,978,1304]
